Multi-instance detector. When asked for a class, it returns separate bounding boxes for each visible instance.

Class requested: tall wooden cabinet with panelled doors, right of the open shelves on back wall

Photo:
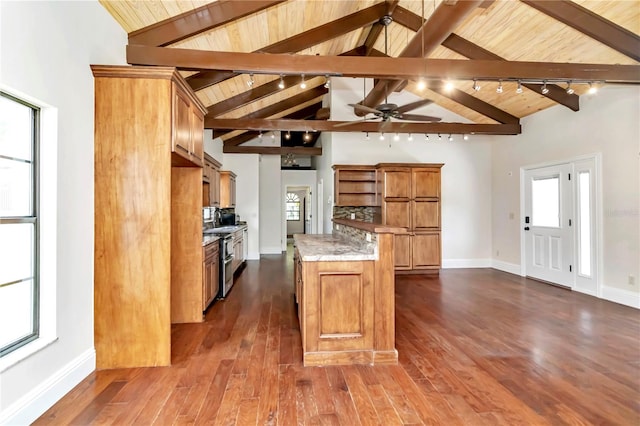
[376,163,443,273]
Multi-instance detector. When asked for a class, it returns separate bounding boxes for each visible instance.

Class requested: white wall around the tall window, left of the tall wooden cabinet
[0,1,127,424]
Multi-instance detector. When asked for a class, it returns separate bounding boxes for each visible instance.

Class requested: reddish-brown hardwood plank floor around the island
[35,254,640,426]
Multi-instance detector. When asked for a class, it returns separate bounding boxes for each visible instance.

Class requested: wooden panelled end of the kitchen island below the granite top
[303,261,374,352]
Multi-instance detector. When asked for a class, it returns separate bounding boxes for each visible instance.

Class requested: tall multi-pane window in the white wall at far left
[0,92,40,357]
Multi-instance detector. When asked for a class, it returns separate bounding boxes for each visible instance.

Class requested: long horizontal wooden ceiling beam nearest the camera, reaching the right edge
[127,45,640,84]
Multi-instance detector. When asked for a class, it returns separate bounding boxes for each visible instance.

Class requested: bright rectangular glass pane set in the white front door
[531,176,560,228]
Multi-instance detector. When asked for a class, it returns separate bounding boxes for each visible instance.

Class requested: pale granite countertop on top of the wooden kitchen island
[293,234,378,262]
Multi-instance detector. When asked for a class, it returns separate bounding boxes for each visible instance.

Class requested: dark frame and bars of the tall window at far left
[0,90,41,359]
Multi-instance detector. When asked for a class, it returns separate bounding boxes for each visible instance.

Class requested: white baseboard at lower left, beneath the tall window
[0,348,96,425]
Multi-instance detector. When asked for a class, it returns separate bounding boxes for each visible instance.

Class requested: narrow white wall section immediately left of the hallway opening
[260,155,282,254]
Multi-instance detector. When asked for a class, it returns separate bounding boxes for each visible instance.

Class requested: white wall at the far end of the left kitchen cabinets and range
[222,154,261,259]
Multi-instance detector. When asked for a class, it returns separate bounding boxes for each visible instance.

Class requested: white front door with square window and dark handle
[523,163,574,288]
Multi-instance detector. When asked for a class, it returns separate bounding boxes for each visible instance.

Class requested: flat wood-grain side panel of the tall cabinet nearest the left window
[94,77,171,369]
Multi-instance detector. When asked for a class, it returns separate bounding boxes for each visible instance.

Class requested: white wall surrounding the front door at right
[492,86,640,307]
